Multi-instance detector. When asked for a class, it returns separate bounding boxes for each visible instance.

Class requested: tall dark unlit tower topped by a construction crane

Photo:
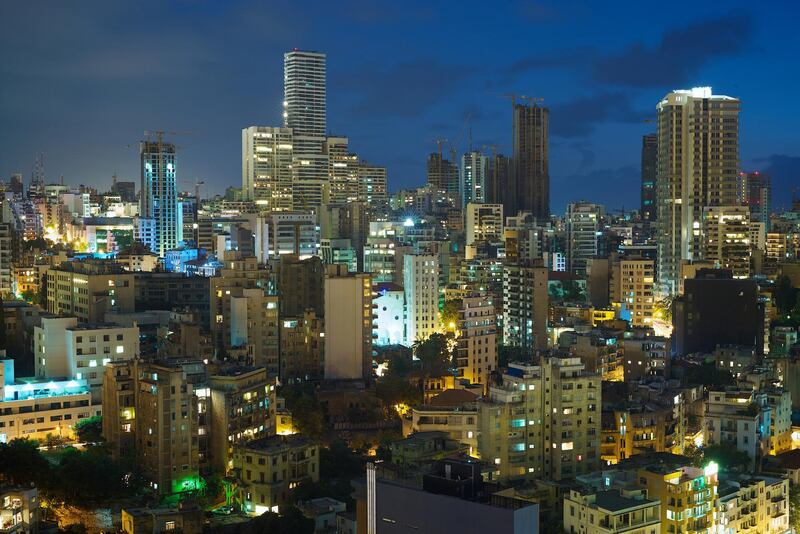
[508,101,550,221]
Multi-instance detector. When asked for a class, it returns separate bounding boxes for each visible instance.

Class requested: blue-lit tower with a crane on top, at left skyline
[139,137,183,257]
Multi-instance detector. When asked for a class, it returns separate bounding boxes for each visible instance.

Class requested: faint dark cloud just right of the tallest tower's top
[334,59,470,118]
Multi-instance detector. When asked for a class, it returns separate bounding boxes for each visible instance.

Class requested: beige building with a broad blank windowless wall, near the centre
[325,272,372,380]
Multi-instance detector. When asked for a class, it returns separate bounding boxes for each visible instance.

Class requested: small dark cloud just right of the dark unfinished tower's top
[550,92,648,137]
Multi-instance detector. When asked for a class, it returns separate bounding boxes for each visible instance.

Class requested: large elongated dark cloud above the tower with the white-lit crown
[591,13,753,87]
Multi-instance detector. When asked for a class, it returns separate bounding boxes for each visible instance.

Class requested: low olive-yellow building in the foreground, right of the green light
[233,434,319,515]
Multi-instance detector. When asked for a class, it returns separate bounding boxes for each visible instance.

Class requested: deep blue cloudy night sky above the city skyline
[0,0,800,213]
